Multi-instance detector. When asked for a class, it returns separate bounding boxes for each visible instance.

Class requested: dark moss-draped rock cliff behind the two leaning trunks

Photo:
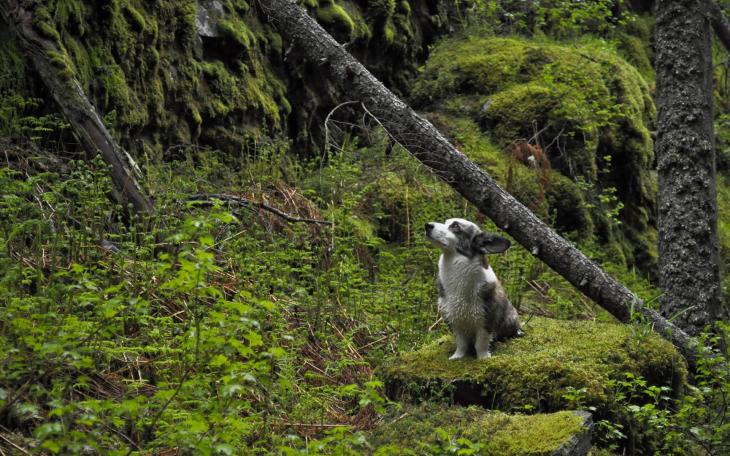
[0,0,447,156]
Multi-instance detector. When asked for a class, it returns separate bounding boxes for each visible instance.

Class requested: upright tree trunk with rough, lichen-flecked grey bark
[655,0,722,334]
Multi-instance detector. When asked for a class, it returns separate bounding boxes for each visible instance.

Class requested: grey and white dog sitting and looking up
[426,218,522,360]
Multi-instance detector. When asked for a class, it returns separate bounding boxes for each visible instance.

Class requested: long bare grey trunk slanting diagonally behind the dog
[259,0,696,364]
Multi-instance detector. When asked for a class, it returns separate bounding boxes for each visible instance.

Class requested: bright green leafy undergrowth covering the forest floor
[0,143,717,454]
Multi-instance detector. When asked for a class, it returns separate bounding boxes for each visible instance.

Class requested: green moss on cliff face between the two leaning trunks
[9,0,291,152]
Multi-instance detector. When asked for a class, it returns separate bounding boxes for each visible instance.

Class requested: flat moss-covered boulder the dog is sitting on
[381,317,687,417]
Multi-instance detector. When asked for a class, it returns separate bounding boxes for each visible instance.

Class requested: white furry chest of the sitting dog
[439,255,497,325]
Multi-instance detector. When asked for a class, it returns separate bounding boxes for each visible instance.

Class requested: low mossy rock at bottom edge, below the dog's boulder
[371,404,592,456]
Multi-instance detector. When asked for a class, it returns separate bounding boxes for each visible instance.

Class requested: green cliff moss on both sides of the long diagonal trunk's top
[7,0,420,154]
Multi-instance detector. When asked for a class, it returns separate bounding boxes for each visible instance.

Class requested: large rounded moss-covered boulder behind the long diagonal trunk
[413,32,656,269]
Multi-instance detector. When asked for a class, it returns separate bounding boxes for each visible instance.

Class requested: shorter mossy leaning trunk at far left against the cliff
[0,0,152,213]
